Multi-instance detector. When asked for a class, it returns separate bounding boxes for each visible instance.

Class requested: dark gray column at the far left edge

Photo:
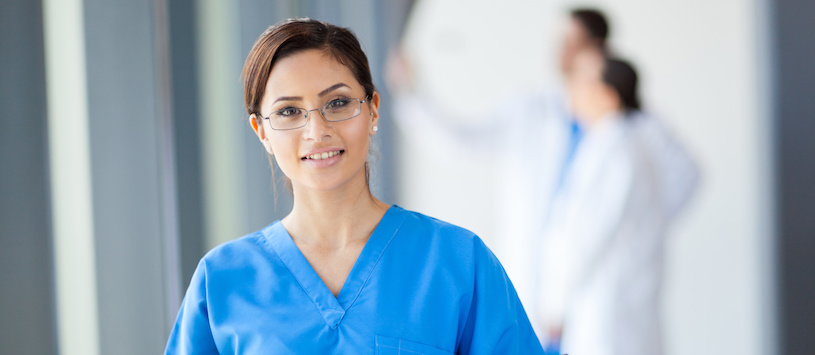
[0,0,56,354]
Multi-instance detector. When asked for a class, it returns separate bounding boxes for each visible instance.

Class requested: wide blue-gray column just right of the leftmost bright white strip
[84,0,178,354]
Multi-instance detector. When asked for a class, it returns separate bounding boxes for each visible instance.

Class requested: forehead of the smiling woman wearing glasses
[264,49,362,101]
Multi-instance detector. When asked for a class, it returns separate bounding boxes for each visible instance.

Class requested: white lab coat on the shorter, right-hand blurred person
[536,112,684,355]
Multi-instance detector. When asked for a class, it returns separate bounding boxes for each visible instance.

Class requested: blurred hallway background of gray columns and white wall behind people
[0,0,815,355]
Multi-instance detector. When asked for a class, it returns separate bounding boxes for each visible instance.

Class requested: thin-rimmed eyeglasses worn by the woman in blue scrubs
[263,97,368,131]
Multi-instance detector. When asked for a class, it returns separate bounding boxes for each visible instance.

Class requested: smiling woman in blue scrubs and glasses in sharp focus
[165,19,543,354]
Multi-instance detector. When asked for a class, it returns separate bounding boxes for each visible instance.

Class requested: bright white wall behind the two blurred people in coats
[397,0,774,354]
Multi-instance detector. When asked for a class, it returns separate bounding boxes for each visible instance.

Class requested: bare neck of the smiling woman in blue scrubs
[282,171,389,248]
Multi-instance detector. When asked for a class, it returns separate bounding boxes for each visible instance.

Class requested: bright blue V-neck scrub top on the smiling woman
[165,206,543,354]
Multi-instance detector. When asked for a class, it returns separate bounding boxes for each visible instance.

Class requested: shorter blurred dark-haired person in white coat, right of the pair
[535,50,696,355]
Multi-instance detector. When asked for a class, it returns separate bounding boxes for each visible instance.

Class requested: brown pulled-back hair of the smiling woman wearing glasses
[241,18,376,193]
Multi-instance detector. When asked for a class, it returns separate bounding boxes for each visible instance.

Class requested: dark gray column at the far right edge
[771,0,815,354]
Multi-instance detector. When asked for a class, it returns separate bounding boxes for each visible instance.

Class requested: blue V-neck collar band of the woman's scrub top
[264,205,406,329]
